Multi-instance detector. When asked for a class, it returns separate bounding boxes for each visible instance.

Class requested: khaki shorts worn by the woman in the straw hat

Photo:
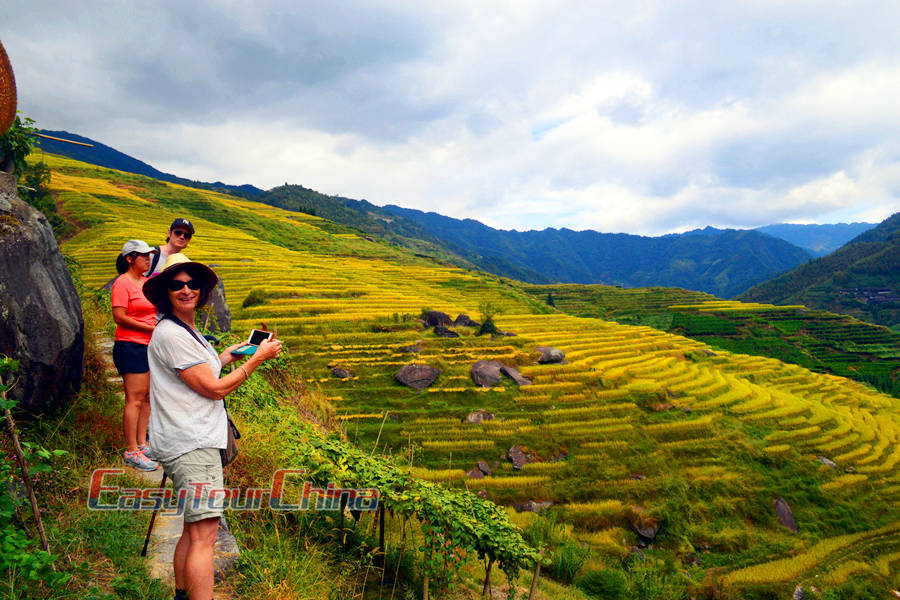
[163,448,225,523]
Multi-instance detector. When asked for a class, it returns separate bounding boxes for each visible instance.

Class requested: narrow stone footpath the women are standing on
[97,333,240,600]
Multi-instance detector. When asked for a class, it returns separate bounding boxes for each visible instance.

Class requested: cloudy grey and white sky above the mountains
[0,0,900,235]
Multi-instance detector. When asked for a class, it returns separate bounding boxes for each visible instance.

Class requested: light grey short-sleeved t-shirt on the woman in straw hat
[147,319,228,462]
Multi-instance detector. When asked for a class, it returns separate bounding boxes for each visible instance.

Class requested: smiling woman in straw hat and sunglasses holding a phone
[144,253,281,600]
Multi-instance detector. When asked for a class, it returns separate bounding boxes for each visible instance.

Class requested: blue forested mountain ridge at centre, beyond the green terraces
[384,205,809,298]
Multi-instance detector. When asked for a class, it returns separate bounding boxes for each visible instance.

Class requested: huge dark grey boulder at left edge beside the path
[0,172,84,414]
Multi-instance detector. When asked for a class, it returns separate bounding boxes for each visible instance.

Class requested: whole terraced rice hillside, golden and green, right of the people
[46,156,900,598]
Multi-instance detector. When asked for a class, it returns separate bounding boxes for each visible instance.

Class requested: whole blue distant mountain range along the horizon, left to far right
[39,131,866,297]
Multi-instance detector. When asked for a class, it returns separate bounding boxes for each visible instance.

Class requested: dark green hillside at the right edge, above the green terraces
[738,213,900,328]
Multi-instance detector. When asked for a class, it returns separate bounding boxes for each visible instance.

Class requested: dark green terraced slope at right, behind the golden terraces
[525,285,900,397]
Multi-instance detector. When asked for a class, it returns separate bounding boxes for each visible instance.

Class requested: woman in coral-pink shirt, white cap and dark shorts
[112,240,159,471]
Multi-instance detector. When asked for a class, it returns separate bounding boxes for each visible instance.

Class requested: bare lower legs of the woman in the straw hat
[172,517,219,600]
